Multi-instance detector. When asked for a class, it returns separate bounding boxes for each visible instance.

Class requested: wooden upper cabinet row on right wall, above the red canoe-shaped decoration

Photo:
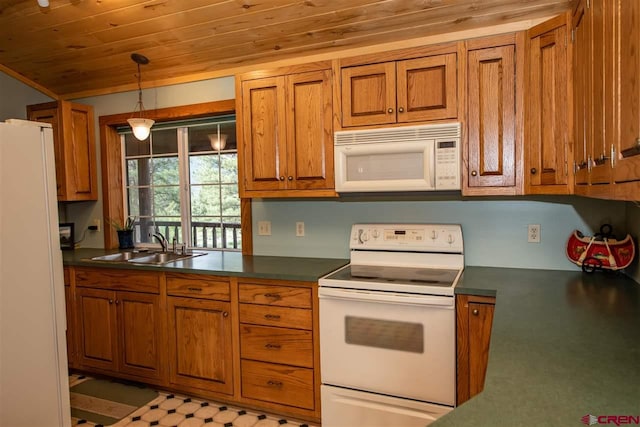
[572,0,640,200]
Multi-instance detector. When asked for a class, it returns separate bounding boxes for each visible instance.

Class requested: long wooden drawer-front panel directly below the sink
[75,268,160,294]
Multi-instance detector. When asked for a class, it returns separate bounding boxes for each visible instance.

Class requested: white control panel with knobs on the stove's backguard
[349,224,463,253]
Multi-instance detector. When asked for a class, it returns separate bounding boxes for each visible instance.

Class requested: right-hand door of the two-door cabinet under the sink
[116,292,163,379]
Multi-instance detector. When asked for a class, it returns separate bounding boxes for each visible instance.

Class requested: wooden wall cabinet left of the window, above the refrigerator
[27,101,98,202]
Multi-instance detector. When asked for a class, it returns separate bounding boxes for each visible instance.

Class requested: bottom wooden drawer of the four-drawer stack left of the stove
[241,360,314,409]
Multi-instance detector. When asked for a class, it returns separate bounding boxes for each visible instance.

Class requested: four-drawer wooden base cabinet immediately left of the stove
[238,281,320,418]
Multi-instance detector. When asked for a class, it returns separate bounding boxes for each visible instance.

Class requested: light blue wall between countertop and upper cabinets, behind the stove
[252,196,625,270]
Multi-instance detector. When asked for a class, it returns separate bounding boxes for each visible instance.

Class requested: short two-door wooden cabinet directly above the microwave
[340,52,458,127]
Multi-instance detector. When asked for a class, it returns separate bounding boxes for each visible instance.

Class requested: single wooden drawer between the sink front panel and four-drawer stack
[167,274,230,301]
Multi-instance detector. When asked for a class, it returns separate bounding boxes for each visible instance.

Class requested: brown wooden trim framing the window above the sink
[99,99,253,255]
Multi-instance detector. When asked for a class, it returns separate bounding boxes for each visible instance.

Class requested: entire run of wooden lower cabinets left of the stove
[67,267,320,423]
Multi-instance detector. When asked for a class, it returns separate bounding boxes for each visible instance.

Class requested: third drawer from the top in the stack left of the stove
[240,325,313,368]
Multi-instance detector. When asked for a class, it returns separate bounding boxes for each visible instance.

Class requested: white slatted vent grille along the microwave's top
[334,123,460,144]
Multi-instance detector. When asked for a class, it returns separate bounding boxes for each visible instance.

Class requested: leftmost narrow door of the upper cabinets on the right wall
[573,1,593,185]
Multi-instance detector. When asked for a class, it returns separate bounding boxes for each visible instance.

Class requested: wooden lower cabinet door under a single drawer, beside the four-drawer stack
[168,297,233,394]
